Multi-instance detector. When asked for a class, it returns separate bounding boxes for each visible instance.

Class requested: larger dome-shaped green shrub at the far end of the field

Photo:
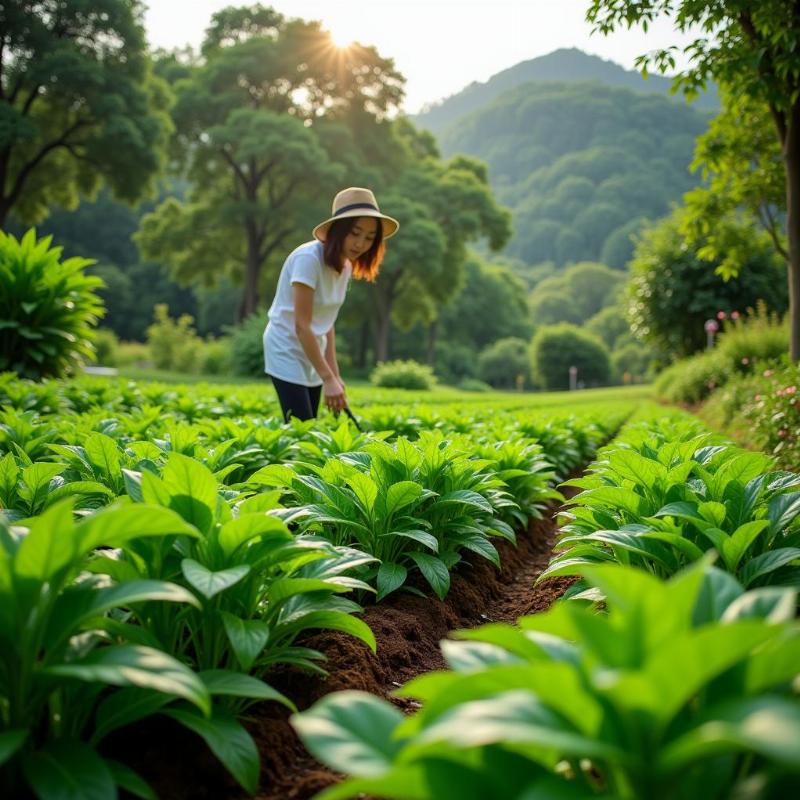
[531,322,611,389]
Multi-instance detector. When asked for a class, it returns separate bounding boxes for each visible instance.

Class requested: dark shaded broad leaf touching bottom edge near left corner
[22,740,117,800]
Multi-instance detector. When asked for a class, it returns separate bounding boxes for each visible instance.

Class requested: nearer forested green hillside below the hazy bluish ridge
[439,82,709,268]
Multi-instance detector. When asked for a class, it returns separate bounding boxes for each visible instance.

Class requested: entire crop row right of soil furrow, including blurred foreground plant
[293,416,800,800]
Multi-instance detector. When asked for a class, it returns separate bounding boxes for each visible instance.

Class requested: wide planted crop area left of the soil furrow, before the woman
[0,376,625,798]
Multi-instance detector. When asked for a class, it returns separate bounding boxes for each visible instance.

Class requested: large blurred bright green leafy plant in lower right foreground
[292,563,800,800]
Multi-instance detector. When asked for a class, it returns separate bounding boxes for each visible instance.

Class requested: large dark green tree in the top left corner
[0,0,171,225]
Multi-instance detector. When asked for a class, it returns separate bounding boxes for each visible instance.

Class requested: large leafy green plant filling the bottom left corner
[0,500,211,800]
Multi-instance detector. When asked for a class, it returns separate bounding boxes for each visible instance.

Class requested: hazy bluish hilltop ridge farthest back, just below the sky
[413,48,719,136]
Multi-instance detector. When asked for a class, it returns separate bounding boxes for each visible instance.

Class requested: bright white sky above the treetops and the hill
[145,0,700,114]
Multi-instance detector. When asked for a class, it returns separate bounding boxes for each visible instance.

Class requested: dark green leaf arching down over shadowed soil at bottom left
[162,708,260,794]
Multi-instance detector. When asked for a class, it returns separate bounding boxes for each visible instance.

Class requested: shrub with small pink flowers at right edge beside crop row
[744,364,800,468]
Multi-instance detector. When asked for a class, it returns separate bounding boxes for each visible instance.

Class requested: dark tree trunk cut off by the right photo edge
[784,101,800,362]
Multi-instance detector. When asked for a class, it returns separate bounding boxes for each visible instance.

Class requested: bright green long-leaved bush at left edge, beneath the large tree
[0,229,105,380]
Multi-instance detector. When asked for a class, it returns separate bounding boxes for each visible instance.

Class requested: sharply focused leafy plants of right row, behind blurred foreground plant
[540,422,800,586]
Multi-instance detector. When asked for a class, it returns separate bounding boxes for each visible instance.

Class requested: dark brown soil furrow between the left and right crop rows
[115,488,572,800]
